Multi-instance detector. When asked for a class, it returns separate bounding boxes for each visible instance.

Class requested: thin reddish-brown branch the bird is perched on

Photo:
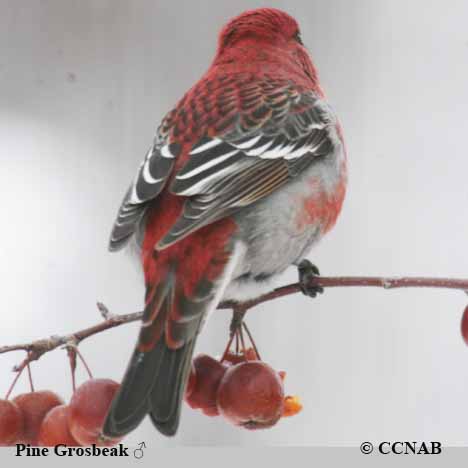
[0,276,468,374]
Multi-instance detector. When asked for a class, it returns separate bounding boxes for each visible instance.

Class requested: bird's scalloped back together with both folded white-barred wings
[109,76,336,250]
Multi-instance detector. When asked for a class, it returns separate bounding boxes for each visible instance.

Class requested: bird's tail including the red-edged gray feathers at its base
[104,273,203,437]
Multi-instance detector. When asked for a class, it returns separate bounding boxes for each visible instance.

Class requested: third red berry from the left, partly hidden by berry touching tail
[37,405,80,447]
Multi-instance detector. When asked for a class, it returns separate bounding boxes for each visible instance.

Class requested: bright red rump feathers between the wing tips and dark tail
[139,186,236,351]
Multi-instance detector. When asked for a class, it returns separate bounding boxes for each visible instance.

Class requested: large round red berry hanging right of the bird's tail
[217,361,284,429]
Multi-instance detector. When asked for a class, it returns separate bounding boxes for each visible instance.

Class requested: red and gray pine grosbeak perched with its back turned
[104,8,346,437]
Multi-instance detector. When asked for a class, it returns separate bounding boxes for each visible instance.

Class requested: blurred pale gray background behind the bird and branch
[0,0,468,447]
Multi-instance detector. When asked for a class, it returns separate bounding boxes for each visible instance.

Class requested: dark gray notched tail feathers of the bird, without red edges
[103,337,195,437]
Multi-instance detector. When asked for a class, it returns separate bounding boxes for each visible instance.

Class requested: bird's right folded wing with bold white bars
[157,84,336,249]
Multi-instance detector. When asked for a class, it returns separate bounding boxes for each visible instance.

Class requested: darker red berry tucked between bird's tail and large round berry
[185,354,227,416]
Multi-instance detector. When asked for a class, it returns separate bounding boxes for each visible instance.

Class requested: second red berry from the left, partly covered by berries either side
[13,390,63,445]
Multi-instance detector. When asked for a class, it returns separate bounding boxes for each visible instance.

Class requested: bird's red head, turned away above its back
[215,8,318,86]
